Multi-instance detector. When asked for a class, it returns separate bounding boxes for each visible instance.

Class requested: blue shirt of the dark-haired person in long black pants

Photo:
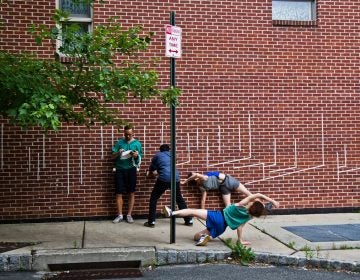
[149,151,180,183]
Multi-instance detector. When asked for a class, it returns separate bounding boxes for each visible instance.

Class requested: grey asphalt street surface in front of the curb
[0,264,360,280]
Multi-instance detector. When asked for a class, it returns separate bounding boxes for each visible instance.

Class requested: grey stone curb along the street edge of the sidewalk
[0,247,360,272]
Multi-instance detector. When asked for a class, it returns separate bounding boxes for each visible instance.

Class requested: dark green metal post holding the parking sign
[170,12,176,243]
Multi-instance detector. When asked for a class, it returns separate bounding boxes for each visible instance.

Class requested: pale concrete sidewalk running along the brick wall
[0,213,360,271]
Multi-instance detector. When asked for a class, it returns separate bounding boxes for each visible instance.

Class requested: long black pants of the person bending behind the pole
[148,179,192,224]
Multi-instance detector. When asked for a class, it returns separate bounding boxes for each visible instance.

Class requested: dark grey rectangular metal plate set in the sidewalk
[283,224,360,242]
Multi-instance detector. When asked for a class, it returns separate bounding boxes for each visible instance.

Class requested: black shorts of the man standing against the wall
[115,167,137,194]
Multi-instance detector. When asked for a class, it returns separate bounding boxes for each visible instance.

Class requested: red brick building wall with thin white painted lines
[0,0,360,220]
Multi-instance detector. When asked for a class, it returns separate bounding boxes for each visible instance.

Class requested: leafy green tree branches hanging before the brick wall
[0,0,180,131]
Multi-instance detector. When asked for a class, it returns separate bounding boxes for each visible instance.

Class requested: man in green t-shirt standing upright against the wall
[112,125,143,223]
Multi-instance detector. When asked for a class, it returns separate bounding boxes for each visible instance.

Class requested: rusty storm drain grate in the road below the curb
[42,268,143,280]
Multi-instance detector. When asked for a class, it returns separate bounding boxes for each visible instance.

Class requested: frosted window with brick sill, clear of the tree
[272,0,316,21]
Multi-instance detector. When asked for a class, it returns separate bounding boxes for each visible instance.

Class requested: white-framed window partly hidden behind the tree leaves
[57,0,93,54]
